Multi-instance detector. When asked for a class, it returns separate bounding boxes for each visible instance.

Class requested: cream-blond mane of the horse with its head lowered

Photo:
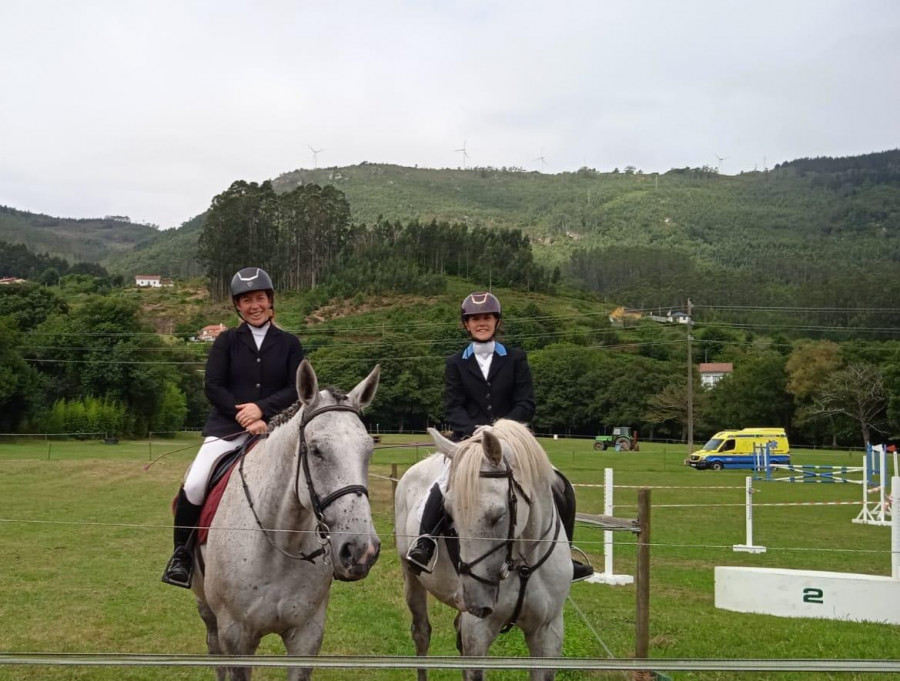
[449,419,553,523]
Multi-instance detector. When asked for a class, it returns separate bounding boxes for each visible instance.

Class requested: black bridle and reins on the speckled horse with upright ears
[238,404,369,563]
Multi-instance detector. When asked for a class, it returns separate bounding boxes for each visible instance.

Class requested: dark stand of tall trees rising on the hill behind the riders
[198,180,559,299]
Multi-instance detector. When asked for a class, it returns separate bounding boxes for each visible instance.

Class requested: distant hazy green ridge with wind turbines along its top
[12,150,900,314]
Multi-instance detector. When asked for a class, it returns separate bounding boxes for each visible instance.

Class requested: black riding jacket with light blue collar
[444,343,534,440]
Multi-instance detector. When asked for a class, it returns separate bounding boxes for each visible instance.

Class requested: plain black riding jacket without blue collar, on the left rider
[203,324,303,437]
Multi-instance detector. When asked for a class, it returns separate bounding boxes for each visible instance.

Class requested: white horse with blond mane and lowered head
[394,420,572,681]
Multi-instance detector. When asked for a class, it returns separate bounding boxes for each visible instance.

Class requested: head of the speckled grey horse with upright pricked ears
[297,360,381,581]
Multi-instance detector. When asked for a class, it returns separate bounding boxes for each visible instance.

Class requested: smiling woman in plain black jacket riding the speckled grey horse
[162,267,303,588]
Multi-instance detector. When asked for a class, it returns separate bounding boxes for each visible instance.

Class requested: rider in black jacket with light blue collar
[406,293,594,581]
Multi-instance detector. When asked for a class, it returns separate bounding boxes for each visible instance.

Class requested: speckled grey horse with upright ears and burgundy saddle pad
[192,360,381,681]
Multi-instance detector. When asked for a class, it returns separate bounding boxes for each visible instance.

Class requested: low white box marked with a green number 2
[715,566,900,624]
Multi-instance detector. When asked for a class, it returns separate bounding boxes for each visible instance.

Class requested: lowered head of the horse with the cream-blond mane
[429,420,552,617]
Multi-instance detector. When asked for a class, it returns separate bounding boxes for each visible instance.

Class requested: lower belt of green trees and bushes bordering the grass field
[0,277,900,446]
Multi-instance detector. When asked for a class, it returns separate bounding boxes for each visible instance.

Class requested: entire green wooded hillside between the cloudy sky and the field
[7,152,900,445]
